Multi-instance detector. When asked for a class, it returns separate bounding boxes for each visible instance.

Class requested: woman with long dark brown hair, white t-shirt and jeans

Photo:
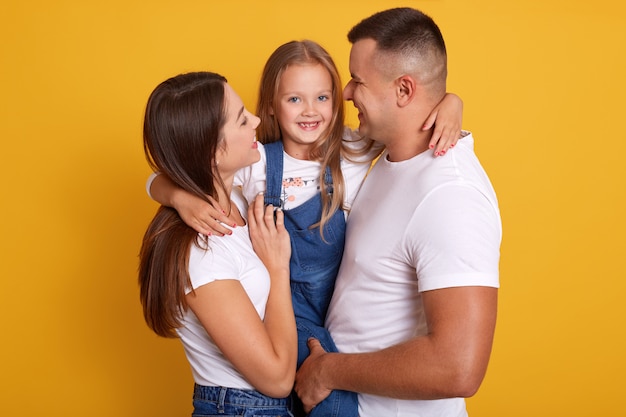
[139,72,297,417]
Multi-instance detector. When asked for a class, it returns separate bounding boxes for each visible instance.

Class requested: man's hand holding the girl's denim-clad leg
[295,339,331,413]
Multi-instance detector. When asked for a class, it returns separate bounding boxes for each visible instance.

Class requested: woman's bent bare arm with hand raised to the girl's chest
[187,196,298,397]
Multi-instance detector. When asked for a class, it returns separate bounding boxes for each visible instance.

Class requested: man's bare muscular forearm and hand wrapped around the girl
[296,287,498,409]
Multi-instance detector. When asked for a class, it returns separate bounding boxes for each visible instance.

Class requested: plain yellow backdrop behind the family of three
[0,0,626,417]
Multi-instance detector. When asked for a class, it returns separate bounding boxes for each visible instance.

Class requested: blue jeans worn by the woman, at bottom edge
[191,384,293,417]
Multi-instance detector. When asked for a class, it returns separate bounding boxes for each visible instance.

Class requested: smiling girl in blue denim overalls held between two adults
[147,41,461,417]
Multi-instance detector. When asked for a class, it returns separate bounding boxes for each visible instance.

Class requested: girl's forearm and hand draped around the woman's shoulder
[146,174,232,236]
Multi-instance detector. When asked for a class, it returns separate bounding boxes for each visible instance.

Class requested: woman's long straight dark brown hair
[139,72,227,337]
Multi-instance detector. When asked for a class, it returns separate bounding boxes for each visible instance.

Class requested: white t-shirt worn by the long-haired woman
[177,189,270,389]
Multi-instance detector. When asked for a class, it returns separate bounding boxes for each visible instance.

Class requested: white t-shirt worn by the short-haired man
[326,134,502,417]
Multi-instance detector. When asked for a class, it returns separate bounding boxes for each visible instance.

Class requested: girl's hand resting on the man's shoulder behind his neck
[422,93,463,156]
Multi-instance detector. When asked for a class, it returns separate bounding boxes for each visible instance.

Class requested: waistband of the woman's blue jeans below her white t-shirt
[193,384,291,407]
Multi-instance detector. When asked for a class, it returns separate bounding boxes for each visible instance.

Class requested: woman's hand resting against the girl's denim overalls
[248,194,291,277]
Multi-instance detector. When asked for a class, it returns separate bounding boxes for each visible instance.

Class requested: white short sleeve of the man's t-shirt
[407,184,502,292]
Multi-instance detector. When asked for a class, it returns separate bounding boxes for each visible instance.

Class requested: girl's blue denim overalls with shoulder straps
[264,141,358,417]
